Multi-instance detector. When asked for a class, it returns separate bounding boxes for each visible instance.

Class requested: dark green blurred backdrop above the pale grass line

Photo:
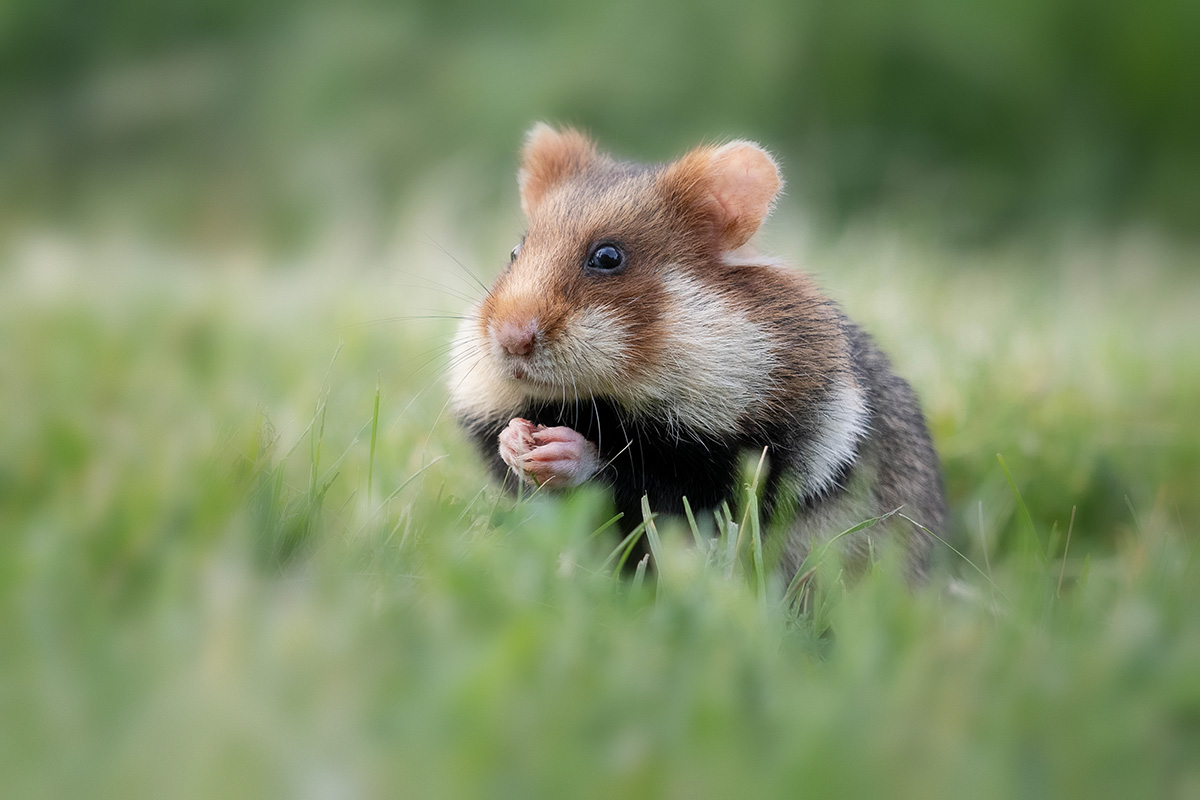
[0,0,1200,247]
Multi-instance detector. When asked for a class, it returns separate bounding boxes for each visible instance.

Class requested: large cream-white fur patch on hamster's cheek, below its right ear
[618,273,778,435]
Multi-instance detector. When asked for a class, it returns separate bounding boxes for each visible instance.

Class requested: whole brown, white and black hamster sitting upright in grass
[449,124,946,581]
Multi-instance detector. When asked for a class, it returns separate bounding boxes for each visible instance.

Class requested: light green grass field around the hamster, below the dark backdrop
[0,225,1200,798]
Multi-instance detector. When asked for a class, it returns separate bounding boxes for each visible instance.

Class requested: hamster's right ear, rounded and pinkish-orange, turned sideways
[661,140,784,249]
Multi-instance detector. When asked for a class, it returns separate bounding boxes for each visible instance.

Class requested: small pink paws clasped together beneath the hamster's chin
[500,417,600,488]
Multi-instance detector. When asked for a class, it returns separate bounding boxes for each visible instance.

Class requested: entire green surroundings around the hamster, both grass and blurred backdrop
[0,0,1200,799]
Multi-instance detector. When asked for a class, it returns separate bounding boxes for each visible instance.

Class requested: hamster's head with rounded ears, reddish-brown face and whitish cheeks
[451,124,782,419]
